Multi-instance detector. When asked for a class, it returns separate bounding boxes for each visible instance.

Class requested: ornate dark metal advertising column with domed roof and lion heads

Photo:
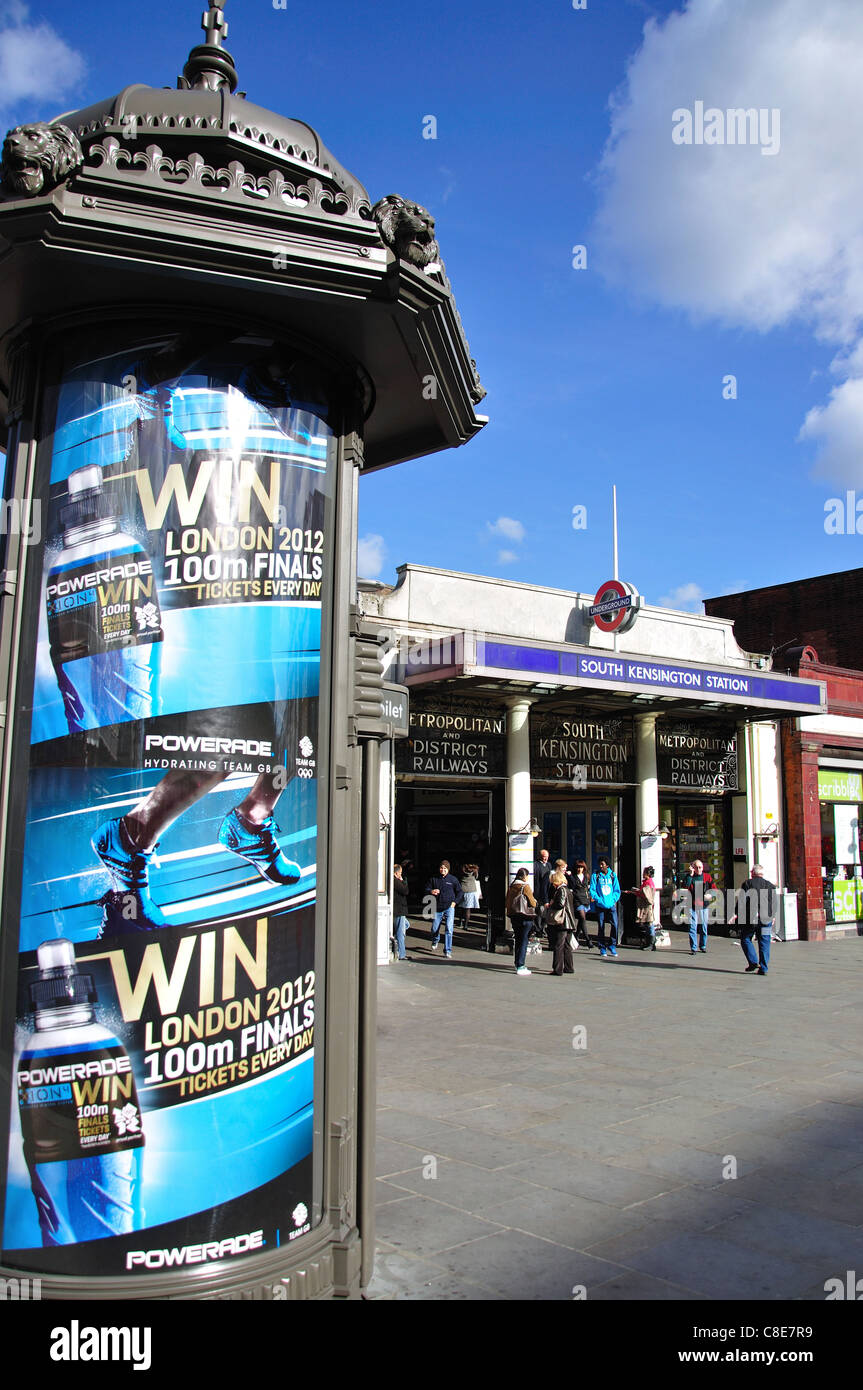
[0,3,484,1300]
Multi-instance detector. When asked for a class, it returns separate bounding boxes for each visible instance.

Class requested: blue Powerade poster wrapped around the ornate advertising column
[3,334,332,1275]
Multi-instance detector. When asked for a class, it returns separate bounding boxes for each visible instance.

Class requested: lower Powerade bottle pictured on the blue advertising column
[17,937,145,1245]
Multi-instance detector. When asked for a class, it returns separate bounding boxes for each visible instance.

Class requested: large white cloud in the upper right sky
[593,0,863,489]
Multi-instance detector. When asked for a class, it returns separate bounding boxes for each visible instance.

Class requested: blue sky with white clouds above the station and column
[6,0,863,607]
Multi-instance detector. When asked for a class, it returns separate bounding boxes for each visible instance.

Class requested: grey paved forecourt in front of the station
[368,924,863,1301]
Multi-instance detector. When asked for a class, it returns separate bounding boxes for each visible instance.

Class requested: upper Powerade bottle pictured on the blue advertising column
[46,464,163,734]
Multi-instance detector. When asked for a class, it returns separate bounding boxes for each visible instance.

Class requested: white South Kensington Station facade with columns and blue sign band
[360,564,827,958]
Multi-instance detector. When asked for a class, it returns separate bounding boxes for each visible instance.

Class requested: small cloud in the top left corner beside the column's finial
[0,0,86,120]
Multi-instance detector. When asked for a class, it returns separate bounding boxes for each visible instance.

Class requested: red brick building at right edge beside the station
[705,569,863,941]
